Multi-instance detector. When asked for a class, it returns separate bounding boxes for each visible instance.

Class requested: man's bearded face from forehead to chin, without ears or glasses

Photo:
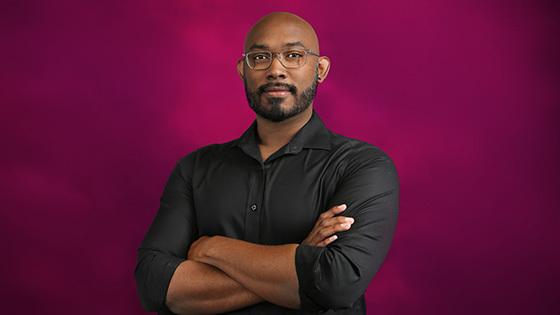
[243,24,319,122]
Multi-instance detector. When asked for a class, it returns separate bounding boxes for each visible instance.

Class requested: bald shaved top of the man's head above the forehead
[243,12,319,53]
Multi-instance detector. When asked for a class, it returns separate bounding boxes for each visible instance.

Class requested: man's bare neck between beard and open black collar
[257,105,313,148]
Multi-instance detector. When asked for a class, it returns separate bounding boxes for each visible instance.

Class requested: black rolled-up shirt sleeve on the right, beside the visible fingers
[295,147,399,312]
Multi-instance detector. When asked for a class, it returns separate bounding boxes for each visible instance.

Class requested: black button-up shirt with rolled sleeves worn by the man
[135,110,399,314]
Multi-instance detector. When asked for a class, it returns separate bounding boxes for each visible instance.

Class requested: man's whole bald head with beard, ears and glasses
[237,12,330,122]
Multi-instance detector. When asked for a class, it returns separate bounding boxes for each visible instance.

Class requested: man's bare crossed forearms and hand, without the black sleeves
[167,206,353,314]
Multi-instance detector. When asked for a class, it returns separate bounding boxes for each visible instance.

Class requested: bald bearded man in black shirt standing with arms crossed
[135,12,399,314]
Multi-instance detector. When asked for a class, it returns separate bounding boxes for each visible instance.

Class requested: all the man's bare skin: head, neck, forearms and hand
[166,12,353,314]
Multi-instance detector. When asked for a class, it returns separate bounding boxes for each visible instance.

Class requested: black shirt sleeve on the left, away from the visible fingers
[134,153,198,314]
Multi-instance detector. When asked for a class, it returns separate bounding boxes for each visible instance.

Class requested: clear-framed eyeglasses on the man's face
[242,49,319,70]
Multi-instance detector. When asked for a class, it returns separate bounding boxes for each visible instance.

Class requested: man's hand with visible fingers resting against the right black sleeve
[301,204,354,247]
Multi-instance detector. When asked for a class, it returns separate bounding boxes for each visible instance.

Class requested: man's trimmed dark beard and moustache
[243,69,319,122]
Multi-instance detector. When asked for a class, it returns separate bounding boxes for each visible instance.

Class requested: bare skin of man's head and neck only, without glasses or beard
[237,12,330,161]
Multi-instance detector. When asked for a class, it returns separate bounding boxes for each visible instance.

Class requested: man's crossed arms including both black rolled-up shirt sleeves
[135,149,398,314]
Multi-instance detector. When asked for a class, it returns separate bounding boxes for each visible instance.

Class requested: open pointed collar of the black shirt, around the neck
[236,109,331,159]
